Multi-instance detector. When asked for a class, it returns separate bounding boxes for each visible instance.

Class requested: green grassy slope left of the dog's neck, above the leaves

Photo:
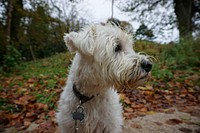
[16,53,72,78]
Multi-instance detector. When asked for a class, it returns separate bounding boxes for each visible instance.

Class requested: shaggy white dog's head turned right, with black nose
[64,24,152,88]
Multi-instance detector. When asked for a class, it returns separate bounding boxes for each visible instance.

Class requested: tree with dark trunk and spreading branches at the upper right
[118,0,200,38]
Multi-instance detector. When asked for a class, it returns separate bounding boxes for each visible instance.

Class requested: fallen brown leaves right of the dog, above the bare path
[120,69,200,119]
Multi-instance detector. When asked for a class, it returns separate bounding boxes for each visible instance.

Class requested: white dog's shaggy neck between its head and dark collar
[71,54,111,97]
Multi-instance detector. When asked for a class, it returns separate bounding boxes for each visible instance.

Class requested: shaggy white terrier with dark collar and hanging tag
[57,24,152,133]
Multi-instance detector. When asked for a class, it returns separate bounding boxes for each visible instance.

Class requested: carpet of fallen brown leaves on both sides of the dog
[0,67,200,132]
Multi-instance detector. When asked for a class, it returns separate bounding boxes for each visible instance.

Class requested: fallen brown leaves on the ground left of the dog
[0,76,66,133]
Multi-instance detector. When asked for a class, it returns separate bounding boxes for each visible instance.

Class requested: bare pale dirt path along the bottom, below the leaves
[3,107,200,133]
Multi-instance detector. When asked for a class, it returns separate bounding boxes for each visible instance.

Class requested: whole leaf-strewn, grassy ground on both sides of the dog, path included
[0,54,200,133]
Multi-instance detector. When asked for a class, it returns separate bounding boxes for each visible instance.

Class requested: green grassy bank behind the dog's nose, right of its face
[134,39,200,70]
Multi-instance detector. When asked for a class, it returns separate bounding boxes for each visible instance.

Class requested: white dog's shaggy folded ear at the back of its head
[64,28,94,55]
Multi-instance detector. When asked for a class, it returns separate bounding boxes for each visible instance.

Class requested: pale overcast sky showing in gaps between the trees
[74,0,178,43]
